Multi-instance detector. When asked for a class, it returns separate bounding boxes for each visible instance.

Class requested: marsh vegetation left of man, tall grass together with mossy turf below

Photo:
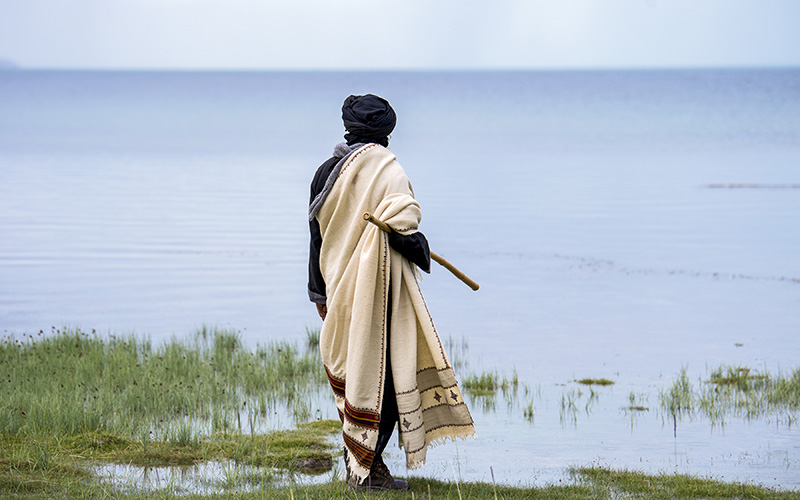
[0,327,341,493]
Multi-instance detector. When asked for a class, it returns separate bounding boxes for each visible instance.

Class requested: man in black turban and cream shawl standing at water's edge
[308,94,474,490]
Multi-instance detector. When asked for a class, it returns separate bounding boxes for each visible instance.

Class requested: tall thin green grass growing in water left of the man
[0,328,327,445]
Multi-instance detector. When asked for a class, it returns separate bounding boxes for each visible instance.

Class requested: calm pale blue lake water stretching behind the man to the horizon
[0,69,800,489]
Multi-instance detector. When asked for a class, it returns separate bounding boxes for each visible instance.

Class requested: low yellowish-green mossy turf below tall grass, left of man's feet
[0,421,341,498]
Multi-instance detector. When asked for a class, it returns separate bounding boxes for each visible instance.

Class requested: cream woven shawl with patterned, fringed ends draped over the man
[317,144,475,479]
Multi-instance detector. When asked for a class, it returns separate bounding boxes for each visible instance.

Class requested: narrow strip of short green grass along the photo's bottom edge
[0,462,799,500]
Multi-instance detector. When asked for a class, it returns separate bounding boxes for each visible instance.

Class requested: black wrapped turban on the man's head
[342,94,397,146]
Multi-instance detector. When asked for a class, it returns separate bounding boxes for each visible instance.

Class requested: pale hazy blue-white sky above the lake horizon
[0,0,800,70]
